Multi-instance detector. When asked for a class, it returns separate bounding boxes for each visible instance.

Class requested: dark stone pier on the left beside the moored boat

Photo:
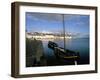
[26,38,47,67]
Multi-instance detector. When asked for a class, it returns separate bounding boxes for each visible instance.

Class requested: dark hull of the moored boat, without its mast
[48,41,80,61]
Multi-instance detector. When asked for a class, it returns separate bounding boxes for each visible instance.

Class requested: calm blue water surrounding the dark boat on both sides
[42,38,90,66]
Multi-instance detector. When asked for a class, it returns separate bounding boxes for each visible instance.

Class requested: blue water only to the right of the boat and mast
[66,38,89,64]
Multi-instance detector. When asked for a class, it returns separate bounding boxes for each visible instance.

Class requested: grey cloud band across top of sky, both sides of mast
[26,12,89,22]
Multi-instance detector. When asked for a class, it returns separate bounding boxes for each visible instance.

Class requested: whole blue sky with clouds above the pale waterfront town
[26,12,89,35]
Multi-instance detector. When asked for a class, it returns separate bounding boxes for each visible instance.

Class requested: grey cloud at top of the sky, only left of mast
[26,12,63,21]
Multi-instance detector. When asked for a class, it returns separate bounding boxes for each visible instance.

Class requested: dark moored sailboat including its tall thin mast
[48,15,80,64]
